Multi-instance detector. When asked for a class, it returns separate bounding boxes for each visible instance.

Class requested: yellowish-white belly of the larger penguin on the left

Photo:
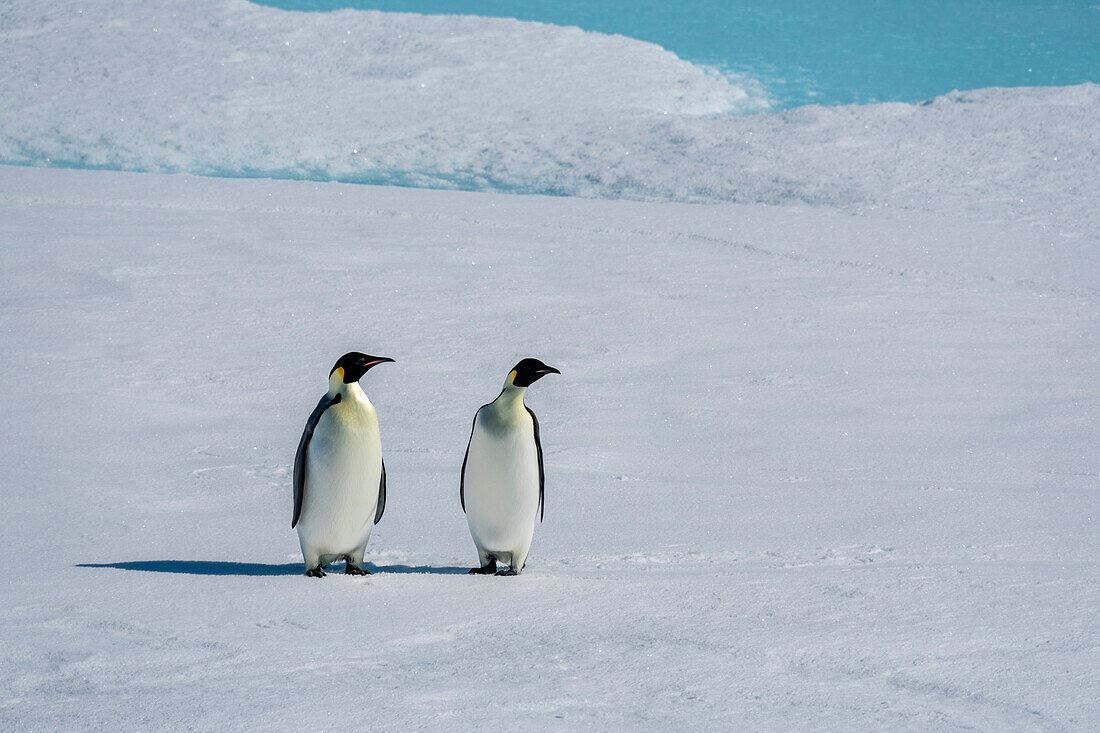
[298,404,382,561]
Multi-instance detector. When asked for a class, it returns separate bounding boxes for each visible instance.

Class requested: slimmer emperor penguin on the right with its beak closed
[459,359,561,576]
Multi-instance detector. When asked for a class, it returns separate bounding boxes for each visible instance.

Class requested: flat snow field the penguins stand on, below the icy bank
[0,166,1100,731]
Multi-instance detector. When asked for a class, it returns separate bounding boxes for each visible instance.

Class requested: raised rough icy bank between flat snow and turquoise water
[0,0,1100,232]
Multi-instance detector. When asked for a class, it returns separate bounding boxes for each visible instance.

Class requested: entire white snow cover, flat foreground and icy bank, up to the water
[0,0,1100,731]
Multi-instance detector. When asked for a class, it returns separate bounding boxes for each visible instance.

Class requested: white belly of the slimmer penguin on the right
[463,426,539,560]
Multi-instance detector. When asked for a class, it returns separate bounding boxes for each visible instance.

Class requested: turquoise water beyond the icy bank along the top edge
[260,0,1100,108]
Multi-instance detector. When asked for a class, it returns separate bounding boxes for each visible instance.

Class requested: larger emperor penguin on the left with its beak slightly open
[290,351,393,578]
